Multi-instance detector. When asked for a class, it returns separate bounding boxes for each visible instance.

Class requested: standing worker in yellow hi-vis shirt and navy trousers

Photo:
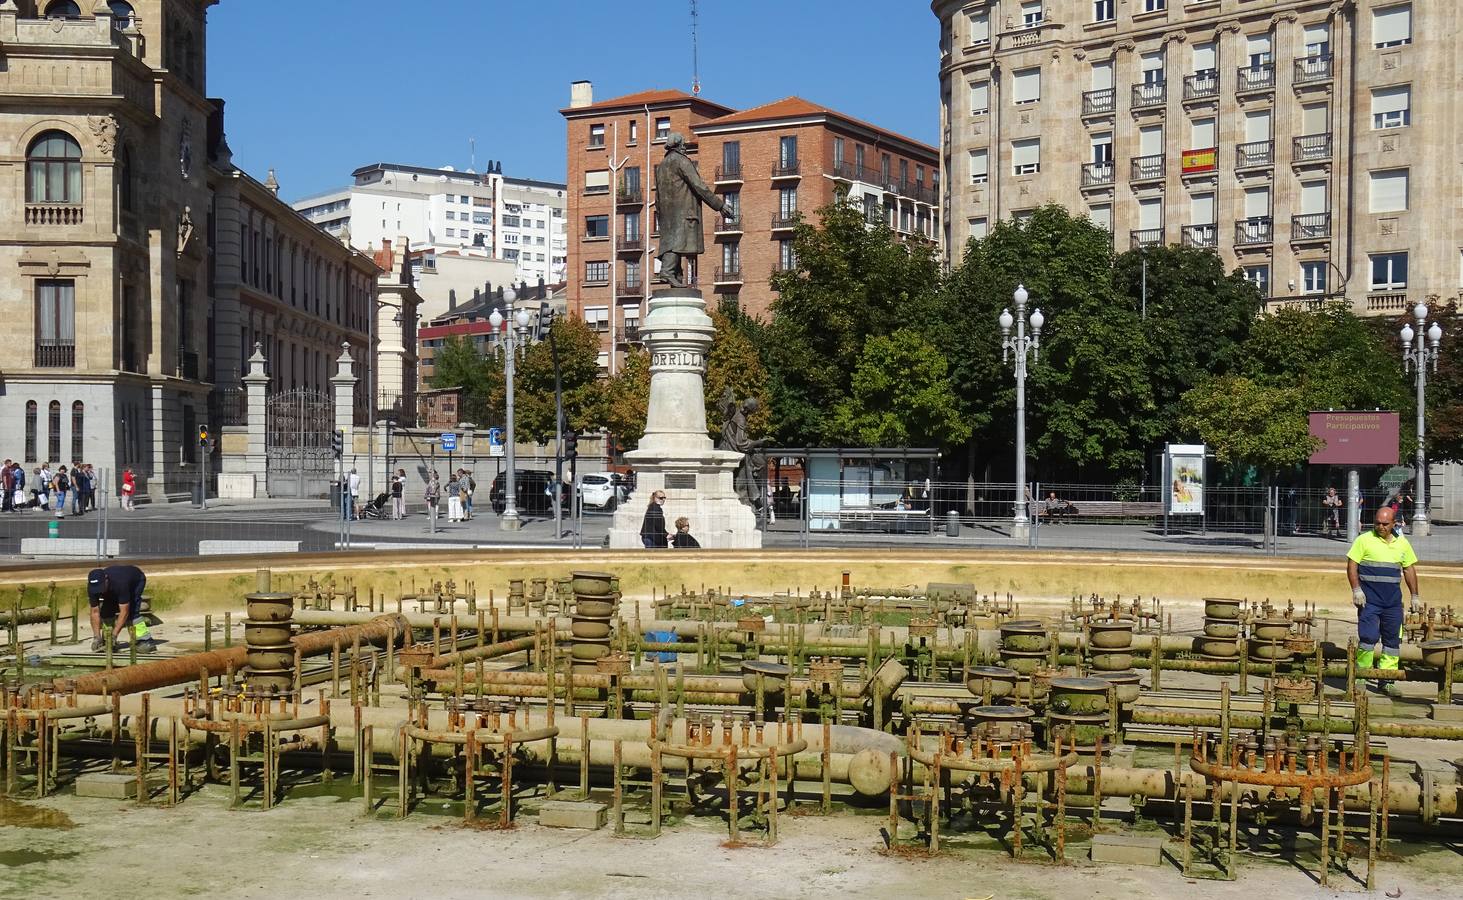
[1346,506,1422,669]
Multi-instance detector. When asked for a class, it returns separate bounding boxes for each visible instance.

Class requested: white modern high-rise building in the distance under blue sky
[294,161,568,287]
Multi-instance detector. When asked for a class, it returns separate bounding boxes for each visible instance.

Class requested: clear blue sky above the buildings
[208,0,939,199]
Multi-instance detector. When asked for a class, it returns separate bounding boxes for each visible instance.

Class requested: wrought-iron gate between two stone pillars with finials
[265,388,335,498]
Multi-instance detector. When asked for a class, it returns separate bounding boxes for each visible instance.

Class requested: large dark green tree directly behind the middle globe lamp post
[920,205,1157,479]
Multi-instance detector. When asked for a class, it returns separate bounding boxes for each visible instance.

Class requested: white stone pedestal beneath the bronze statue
[610,288,762,549]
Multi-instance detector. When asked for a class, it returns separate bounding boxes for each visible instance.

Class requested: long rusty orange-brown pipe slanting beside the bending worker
[53,613,407,695]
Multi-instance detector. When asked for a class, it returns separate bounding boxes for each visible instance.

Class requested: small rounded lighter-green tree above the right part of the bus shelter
[827,328,970,446]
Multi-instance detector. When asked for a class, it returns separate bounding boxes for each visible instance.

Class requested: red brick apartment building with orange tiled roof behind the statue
[560,82,941,373]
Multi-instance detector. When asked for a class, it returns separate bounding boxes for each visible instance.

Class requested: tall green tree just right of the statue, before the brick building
[762,202,939,443]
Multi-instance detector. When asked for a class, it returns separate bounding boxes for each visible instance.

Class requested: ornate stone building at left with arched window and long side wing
[0,0,377,500]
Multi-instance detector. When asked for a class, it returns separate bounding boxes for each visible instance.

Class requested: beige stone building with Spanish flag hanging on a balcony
[930,0,1463,315]
